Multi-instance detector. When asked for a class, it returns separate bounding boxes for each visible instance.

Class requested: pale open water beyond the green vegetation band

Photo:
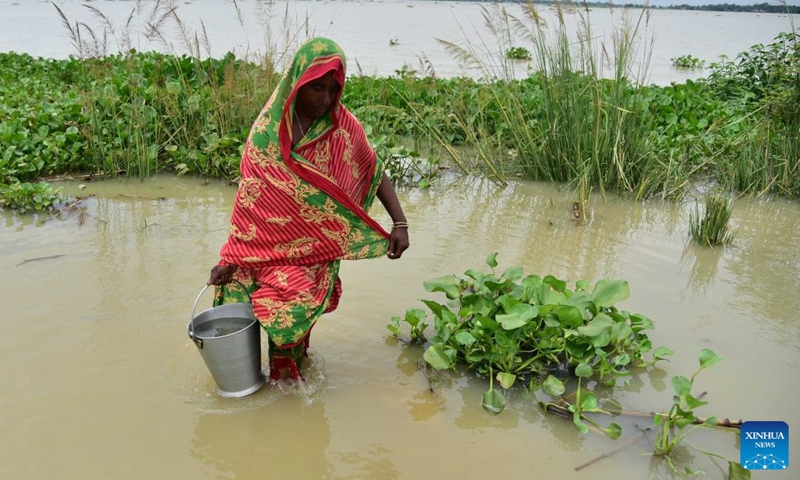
[0,0,800,84]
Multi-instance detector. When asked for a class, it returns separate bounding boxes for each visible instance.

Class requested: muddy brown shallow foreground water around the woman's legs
[0,176,800,480]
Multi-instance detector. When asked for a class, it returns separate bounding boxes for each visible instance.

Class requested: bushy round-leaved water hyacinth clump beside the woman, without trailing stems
[388,253,672,414]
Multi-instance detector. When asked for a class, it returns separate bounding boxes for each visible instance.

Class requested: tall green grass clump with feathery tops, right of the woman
[422,2,674,201]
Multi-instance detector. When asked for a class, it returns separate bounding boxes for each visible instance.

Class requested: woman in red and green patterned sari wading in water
[208,38,409,381]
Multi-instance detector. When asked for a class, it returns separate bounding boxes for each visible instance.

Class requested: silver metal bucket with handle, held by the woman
[186,285,265,397]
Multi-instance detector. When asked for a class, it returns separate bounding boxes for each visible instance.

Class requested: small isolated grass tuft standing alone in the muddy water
[689,192,735,246]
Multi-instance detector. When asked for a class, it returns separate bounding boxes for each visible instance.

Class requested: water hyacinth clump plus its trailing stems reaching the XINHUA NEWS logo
[387,253,750,480]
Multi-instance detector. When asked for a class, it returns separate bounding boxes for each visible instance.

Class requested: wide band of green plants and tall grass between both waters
[0,2,800,214]
